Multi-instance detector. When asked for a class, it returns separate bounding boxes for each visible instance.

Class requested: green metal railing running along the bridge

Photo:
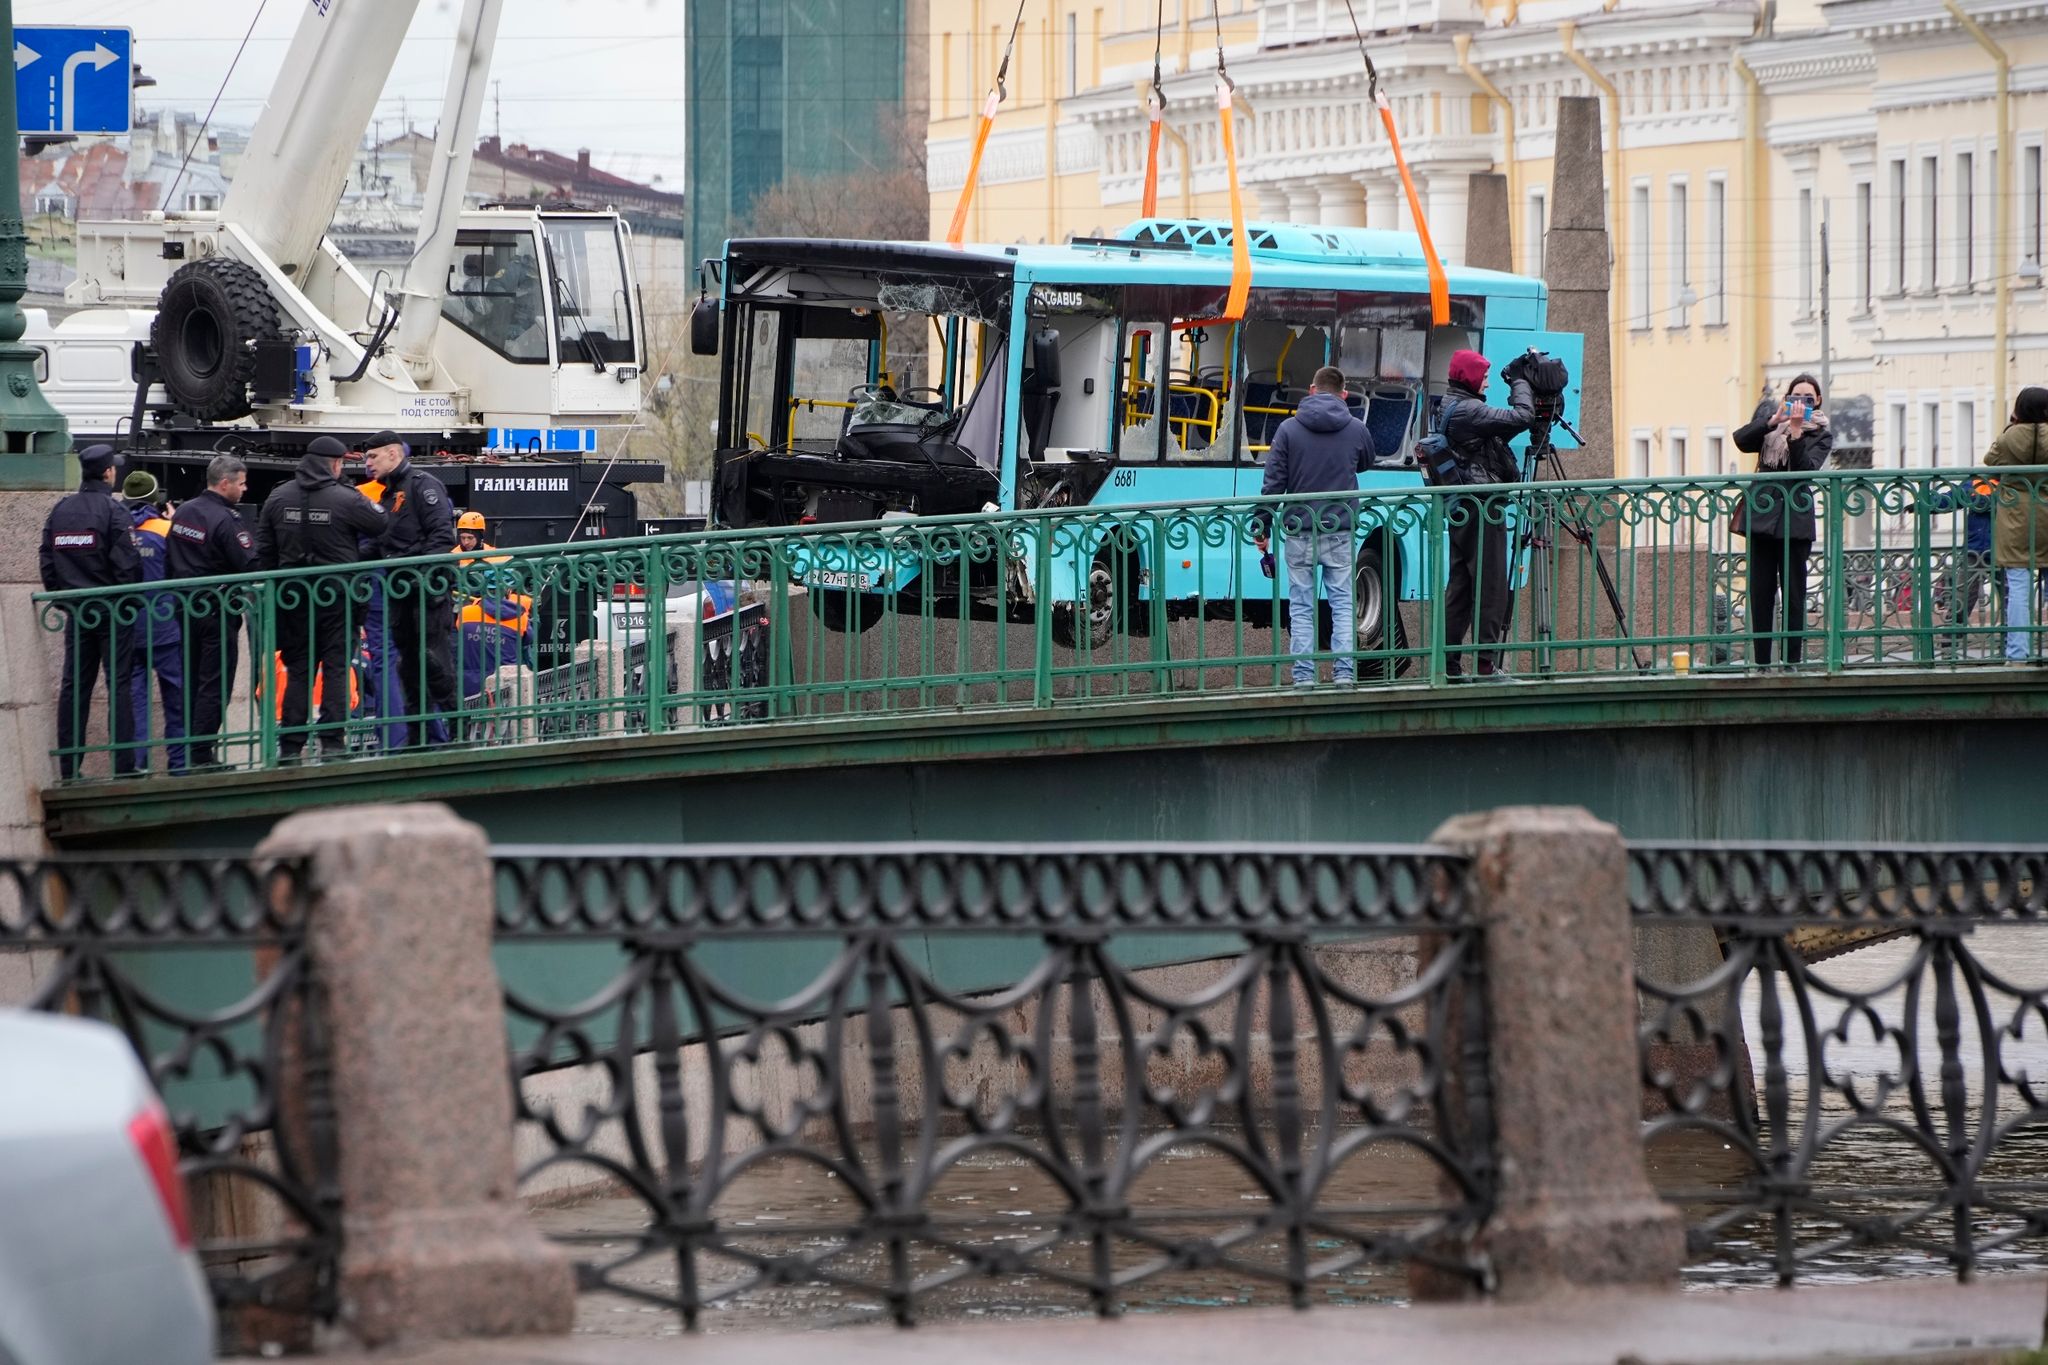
[37,469,2048,778]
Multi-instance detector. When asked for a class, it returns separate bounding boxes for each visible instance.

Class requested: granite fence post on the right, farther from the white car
[1434,806,1686,1300]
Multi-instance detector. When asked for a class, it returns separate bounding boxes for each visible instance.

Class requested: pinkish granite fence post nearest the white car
[256,804,575,1347]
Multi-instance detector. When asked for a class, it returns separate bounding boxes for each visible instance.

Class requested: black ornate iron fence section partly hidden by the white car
[0,855,342,1349]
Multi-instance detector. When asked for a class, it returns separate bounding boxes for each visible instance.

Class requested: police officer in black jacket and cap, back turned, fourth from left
[256,436,385,763]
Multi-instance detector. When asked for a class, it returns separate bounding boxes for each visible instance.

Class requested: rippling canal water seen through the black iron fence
[543,925,2048,1336]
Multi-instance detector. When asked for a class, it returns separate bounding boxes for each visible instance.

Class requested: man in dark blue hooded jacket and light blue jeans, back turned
[1251,364,1374,688]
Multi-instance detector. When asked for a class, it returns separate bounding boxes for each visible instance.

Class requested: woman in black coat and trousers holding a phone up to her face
[1735,375,1835,667]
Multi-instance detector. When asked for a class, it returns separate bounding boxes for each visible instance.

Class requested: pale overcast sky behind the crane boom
[14,0,684,188]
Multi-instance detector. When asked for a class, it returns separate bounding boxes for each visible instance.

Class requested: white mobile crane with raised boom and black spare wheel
[29,0,662,542]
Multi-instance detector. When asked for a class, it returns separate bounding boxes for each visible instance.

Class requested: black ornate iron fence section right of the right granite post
[1630,845,2048,1283]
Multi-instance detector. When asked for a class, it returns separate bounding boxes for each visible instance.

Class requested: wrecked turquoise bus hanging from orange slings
[692,219,1583,667]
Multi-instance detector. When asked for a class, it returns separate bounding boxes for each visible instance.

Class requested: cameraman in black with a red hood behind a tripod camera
[1442,350,1540,679]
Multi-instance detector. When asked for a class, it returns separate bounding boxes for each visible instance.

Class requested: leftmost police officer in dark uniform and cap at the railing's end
[39,446,145,778]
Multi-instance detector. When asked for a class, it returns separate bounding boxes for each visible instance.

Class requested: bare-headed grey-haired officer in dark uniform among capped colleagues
[164,454,256,769]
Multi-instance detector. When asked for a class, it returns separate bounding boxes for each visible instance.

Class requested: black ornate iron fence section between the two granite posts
[496,845,1493,1324]
